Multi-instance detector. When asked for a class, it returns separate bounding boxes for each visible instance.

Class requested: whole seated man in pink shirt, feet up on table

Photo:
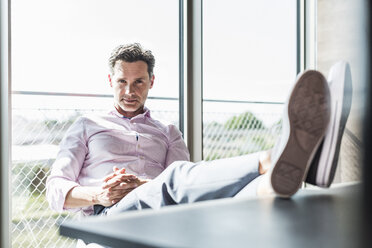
[47,44,351,218]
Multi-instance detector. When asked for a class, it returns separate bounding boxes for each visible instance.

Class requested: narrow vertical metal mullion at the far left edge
[0,0,11,247]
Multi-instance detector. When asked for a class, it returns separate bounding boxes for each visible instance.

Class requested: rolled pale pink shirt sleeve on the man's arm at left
[46,117,88,212]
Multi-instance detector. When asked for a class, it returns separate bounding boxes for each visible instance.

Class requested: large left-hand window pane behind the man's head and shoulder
[10,0,179,247]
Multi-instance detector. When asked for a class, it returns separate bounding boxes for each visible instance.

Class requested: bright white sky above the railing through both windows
[12,0,296,117]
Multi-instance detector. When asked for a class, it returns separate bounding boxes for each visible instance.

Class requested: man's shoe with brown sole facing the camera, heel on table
[271,70,330,197]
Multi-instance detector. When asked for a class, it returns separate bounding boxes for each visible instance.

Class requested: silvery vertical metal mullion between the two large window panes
[185,0,203,161]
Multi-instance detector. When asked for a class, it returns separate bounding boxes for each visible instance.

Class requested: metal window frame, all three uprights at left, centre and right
[0,0,308,247]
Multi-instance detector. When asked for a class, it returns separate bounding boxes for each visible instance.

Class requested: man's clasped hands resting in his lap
[97,166,149,207]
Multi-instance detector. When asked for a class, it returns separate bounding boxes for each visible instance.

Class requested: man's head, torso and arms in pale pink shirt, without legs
[47,44,189,215]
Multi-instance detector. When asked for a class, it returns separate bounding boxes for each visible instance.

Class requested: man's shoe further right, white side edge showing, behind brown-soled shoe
[306,61,352,187]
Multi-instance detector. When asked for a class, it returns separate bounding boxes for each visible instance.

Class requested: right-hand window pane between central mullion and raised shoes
[203,0,297,160]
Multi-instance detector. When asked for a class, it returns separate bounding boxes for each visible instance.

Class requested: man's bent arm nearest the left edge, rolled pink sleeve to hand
[46,118,134,212]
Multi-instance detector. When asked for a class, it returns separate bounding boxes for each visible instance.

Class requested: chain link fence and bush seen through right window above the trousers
[203,111,281,160]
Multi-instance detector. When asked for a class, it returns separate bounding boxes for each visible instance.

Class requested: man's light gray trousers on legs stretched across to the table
[100,153,260,215]
